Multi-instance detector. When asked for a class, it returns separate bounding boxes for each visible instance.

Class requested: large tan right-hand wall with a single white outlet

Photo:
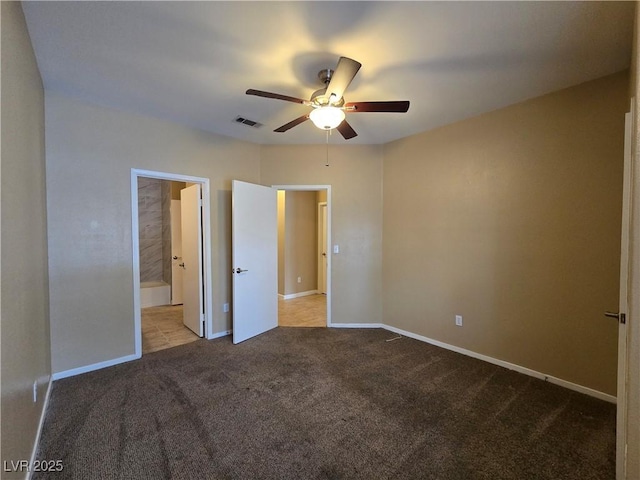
[383,72,628,395]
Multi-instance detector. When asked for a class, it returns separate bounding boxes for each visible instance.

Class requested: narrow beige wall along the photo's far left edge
[0,2,51,478]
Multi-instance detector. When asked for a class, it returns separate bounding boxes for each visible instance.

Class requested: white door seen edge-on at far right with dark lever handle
[607,107,633,479]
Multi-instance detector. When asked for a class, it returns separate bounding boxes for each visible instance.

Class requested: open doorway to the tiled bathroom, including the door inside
[131,169,211,356]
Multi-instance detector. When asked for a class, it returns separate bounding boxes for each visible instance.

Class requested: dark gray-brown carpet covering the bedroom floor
[33,327,615,480]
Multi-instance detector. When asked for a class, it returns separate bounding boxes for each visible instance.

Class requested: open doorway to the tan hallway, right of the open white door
[276,186,330,327]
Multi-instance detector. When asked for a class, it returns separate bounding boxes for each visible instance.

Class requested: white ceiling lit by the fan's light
[23,1,635,144]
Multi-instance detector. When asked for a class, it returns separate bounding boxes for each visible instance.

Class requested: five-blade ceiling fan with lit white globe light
[246,57,409,140]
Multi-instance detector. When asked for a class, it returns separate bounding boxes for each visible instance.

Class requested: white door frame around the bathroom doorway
[131,168,213,358]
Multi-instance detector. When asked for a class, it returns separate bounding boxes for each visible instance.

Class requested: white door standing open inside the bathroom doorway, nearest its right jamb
[180,184,204,337]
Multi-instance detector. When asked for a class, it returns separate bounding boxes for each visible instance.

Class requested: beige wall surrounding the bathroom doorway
[46,92,260,372]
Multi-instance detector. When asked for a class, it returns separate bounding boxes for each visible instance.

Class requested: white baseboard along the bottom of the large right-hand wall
[382,324,616,404]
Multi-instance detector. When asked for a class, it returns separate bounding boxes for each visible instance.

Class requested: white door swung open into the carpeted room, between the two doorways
[231,180,278,343]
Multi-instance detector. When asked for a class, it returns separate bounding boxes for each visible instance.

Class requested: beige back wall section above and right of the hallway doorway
[261,145,382,323]
